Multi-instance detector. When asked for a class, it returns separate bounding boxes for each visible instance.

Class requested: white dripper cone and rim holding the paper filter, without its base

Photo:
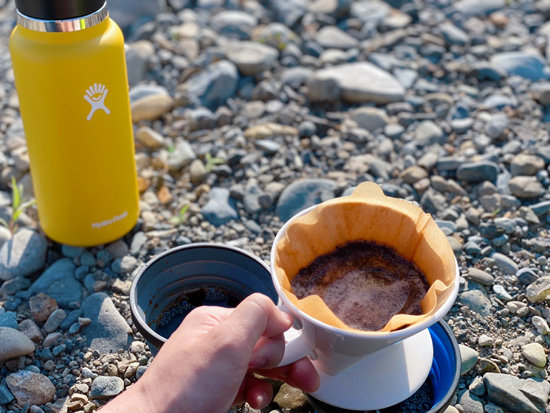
[271,205,459,375]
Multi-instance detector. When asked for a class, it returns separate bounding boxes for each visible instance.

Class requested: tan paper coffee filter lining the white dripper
[274,182,456,333]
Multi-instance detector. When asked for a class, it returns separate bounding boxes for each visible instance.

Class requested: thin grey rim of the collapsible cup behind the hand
[130,242,271,347]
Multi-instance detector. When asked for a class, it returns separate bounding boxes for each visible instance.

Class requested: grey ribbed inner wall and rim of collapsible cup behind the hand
[130,243,278,352]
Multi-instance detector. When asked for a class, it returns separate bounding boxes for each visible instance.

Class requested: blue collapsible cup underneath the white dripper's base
[308,321,462,413]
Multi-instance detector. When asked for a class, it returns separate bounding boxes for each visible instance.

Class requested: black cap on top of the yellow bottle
[15,0,105,20]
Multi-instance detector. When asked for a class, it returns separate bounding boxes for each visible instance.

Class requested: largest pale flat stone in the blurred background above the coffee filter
[308,62,405,104]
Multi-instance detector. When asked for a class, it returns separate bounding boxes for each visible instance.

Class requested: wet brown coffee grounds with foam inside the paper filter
[291,241,429,331]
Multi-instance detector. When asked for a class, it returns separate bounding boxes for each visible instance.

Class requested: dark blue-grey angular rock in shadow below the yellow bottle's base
[29,258,82,307]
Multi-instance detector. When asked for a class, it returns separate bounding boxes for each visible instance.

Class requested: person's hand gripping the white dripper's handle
[102,294,319,413]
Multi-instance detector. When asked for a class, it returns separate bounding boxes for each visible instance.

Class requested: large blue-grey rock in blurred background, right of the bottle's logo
[180,60,239,108]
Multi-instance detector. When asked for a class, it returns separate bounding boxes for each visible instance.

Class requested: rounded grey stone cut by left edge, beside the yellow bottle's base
[0,228,47,281]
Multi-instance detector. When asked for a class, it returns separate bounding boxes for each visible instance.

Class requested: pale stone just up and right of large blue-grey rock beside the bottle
[225,42,279,76]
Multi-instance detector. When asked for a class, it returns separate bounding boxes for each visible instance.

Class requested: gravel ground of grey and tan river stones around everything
[0,0,550,413]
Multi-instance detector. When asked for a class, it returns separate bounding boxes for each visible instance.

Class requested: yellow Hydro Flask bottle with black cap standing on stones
[10,0,139,246]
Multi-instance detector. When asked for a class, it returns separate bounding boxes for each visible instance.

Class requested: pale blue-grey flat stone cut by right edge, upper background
[490,52,546,80]
